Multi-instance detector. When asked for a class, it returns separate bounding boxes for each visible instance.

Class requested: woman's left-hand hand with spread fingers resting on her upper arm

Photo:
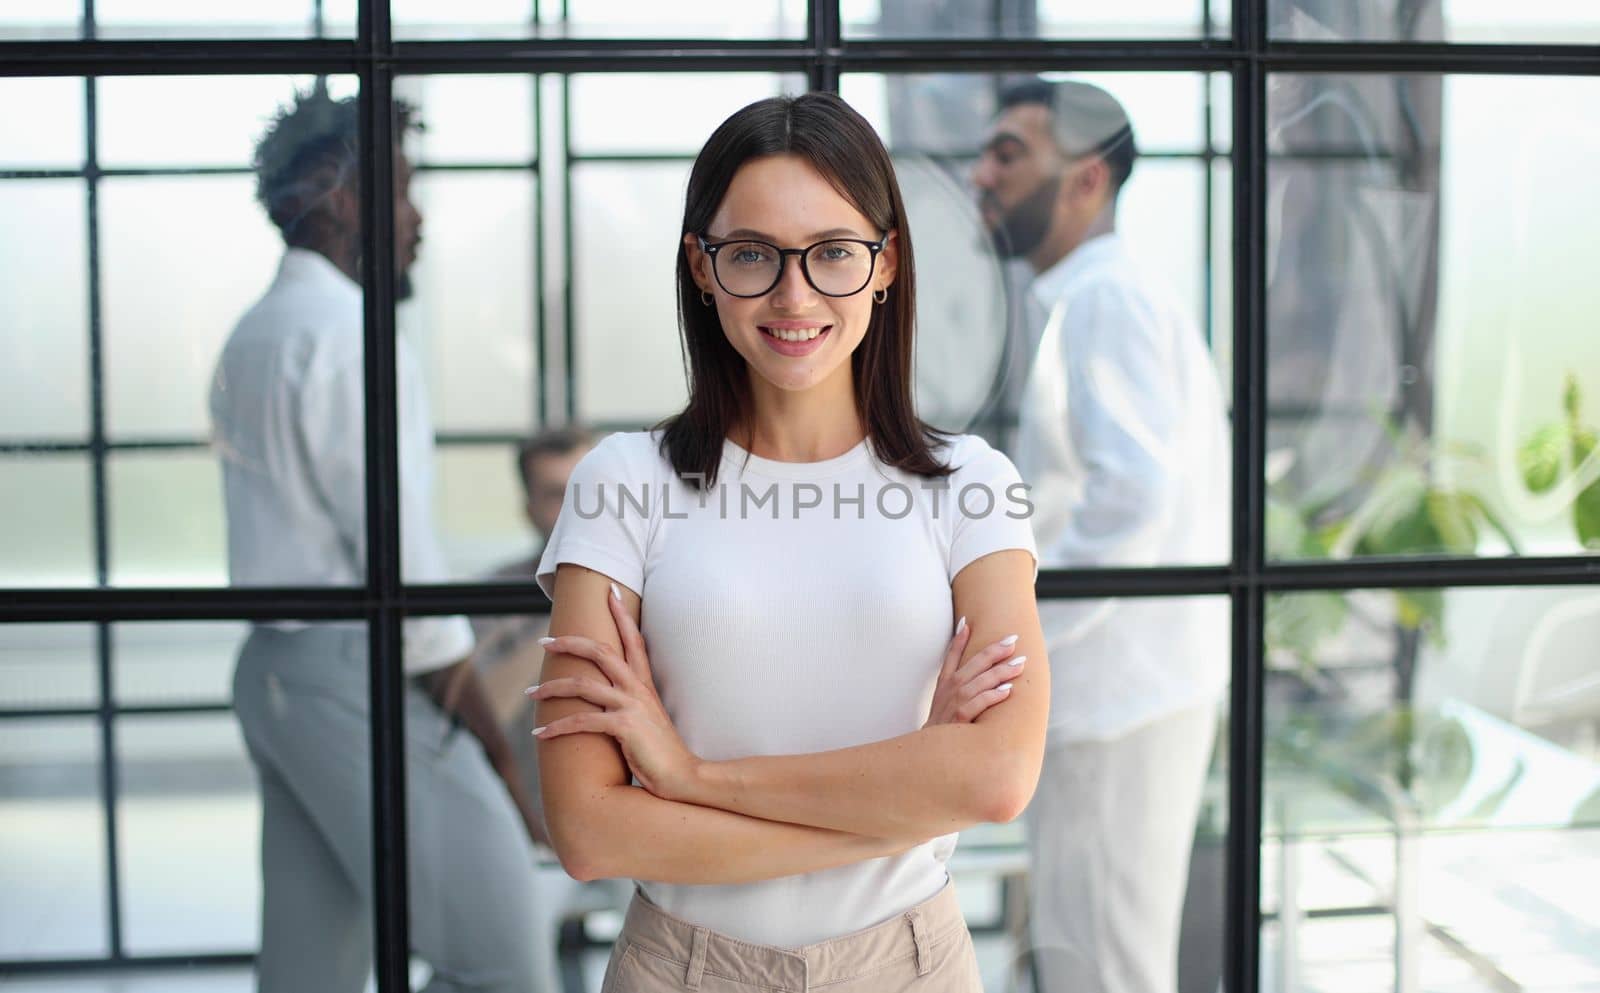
[526,584,701,800]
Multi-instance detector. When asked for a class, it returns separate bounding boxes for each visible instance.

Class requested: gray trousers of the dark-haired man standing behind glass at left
[234,625,544,993]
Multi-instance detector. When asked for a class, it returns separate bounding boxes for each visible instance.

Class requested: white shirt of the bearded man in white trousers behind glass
[1016,233,1230,744]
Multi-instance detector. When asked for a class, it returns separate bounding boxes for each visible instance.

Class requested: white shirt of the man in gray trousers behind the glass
[211,248,472,675]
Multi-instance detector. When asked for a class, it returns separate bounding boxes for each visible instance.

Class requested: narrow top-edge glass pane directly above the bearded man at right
[840,0,1229,40]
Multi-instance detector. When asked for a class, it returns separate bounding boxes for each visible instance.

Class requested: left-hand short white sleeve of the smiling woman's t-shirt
[534,432,661,600]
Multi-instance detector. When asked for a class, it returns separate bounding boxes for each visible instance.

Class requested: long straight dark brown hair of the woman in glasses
[656,93,950,488]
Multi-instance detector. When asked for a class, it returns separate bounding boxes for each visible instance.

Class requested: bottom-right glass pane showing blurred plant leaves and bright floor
[1262,587,1600,990]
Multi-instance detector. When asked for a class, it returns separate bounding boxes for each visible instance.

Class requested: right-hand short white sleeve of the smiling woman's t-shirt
[949,435,1038,582]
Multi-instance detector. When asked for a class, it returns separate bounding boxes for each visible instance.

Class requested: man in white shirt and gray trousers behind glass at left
[211,86,538,993]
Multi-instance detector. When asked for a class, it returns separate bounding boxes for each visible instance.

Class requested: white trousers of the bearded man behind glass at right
[1024,705,1216,993]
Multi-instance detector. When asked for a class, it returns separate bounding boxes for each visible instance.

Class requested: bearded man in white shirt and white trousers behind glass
[973,80,1229,993]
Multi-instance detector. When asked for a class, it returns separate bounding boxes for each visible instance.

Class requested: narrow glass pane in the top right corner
[1267,0,1600,45]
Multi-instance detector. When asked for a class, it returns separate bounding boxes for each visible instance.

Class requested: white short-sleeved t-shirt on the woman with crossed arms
[538,432,1037,948]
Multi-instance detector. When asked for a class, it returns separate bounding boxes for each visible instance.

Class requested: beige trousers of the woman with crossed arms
[600,883,984,993]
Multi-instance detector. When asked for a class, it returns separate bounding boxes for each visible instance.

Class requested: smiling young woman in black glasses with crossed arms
[530,94,1050,993]
